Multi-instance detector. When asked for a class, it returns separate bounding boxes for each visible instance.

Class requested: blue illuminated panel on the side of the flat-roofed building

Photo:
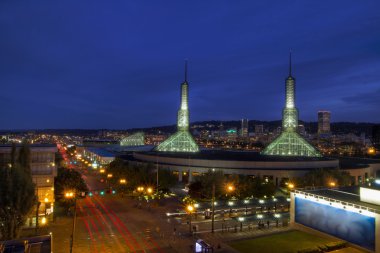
[295,197,375,251]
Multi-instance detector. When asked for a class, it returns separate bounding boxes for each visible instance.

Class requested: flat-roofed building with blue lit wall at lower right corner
[290,187,380,253]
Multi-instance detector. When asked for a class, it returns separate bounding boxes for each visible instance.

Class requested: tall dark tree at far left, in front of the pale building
[0,143,36,240]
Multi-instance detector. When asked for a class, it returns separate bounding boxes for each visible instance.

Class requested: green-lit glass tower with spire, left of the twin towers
[156,61,199,152]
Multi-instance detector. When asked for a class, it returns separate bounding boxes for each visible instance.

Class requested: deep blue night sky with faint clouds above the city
[0,0,380,129]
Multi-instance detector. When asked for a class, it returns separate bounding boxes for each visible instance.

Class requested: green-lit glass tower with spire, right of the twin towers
[262,52,322,157]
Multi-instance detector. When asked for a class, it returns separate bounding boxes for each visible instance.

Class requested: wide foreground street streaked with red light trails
[52,168,191,253]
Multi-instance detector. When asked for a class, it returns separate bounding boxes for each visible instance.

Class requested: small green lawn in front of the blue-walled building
[230,231,332,253]
